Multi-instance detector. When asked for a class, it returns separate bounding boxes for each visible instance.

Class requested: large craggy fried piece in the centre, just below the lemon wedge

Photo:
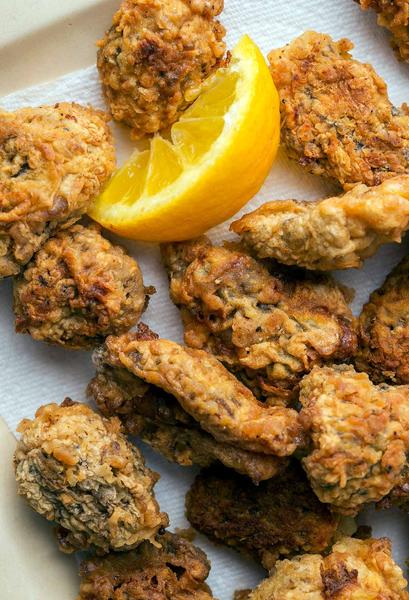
[162,237,357,404]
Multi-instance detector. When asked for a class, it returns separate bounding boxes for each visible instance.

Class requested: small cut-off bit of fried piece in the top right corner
[355,0,409,62]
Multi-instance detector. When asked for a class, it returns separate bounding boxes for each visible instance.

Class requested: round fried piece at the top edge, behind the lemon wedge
[97,0,226,138]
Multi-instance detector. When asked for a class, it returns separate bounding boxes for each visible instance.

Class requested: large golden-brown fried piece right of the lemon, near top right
[268,31,409,187]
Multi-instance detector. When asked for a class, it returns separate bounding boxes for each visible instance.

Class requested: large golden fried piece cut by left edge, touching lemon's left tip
[0,102,115,278]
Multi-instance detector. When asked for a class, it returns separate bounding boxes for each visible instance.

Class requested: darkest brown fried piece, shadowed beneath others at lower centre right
[186,463,340,570]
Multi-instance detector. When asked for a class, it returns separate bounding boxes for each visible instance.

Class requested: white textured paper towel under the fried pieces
[0,0,409,600]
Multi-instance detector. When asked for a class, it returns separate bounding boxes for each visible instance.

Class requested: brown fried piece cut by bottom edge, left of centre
[77,533,213,600]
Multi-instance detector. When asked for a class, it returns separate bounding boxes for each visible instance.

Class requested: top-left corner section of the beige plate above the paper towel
[0,0,119,96]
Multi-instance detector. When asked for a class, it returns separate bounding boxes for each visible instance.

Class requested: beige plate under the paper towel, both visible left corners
[0,0,113,600]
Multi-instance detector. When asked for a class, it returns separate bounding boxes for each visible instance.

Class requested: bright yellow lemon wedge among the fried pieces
[89,36,280,242]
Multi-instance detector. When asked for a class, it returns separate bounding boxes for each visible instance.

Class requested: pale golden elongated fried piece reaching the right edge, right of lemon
[231,175,409,271]
